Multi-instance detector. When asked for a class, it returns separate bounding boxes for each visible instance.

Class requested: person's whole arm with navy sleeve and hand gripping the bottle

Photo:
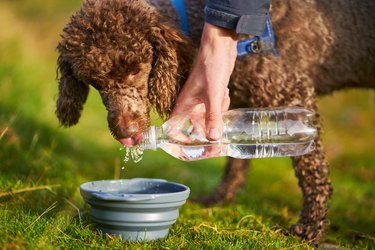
[171,0,270,140]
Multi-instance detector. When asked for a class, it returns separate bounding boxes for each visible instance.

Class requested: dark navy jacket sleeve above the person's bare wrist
[204,0,270,35]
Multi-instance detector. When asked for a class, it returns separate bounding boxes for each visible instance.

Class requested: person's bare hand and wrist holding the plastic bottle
[171,23,237,140]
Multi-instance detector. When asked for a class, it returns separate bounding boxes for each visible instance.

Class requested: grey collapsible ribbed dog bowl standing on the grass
[80,178,190,241]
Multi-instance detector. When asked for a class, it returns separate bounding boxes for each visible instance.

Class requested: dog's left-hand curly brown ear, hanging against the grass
[56,55,89,127]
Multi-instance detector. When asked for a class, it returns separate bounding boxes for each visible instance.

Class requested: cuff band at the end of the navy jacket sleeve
[204,6,267,36]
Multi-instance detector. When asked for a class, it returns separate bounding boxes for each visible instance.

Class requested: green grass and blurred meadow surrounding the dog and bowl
[0,0,375,249]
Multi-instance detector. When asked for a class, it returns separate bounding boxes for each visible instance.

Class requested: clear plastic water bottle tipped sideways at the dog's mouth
[141,107,317,161]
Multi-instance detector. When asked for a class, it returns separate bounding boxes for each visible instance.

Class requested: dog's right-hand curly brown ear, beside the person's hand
[149,23,191,118]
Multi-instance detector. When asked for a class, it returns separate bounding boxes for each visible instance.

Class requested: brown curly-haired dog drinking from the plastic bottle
[56,0,375,243]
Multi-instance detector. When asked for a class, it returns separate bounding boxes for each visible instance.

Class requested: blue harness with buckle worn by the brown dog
[171,0,279,57]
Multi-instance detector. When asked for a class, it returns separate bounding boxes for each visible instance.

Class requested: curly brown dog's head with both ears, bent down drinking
[56,0,193,144]
